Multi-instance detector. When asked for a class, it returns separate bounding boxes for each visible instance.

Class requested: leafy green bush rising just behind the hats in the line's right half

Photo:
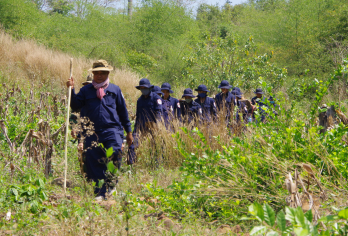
[182,35,287,91]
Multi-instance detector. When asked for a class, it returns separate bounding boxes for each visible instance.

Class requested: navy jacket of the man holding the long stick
[71,84,132,133]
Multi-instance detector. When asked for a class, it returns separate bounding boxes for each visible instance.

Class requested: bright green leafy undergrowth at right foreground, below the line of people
[143,66,348,221]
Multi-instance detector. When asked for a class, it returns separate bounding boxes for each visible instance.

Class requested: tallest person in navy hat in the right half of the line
[215,80,236,124]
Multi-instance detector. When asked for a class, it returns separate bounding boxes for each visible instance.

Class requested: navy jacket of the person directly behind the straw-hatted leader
[133,92,163,133]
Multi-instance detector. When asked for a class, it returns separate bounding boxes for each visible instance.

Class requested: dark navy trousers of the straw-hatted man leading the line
[85,129,123,196]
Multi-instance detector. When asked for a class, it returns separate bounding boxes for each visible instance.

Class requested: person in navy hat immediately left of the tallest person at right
[195,84,216,122]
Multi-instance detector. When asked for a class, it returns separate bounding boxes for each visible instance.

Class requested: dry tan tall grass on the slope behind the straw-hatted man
[0,31,140,102]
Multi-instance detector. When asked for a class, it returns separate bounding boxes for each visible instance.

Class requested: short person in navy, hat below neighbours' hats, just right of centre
[180,88,202,124]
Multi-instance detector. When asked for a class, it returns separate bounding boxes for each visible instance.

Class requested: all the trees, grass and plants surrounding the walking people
[0,0,348,235]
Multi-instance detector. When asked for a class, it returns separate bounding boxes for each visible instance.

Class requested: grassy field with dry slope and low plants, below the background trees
[0,30,348,235]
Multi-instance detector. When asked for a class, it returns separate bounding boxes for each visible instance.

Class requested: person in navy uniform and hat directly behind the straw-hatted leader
[127,78,162,165]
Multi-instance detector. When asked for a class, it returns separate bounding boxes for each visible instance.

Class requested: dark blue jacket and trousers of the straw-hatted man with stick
[71,84,131,196]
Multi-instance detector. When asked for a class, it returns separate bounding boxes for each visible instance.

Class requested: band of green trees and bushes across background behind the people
[0,0,348,94]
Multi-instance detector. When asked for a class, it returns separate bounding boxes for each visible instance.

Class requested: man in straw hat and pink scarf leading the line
[67,60,133,200]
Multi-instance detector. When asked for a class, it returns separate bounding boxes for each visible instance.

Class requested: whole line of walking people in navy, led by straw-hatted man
[67,60,277,199]
